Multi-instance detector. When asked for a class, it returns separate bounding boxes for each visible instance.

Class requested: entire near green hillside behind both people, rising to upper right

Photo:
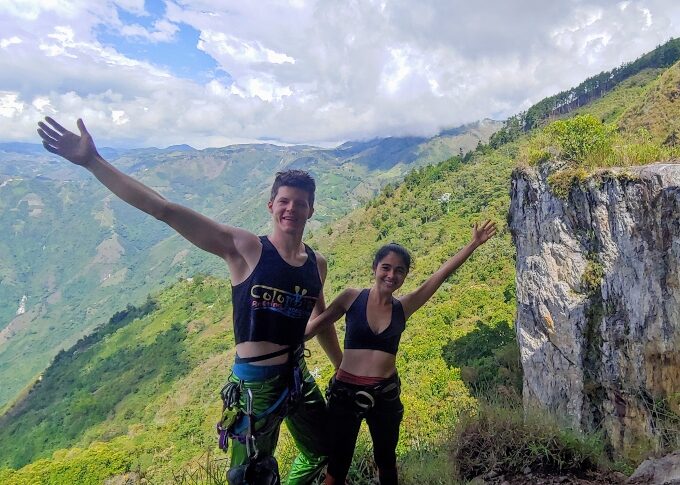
[0,40,677,484]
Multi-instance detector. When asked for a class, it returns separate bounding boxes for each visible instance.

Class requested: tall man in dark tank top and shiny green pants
[38,117,342,484]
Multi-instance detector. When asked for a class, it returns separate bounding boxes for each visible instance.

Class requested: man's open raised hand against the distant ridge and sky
[38,116,99,166]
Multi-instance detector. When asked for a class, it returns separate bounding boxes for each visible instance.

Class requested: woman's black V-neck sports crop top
[345,289,406,355]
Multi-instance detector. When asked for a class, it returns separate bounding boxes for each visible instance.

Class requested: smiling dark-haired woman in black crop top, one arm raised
[305,221,496,485]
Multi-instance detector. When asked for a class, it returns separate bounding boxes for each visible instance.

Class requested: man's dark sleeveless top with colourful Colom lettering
[231,236,322,346]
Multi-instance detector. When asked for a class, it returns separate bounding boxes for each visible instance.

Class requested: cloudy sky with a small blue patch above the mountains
[0,0,680,148]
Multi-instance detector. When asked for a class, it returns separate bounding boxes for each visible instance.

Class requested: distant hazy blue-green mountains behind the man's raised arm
[0,122,497,413]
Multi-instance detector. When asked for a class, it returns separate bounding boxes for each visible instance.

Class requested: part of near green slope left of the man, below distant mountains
[0,278,233,483]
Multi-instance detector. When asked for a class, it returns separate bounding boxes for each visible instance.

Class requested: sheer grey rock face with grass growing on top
[509,164,680,453]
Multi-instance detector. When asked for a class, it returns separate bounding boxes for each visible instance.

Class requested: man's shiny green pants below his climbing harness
[229,358,328,485]
